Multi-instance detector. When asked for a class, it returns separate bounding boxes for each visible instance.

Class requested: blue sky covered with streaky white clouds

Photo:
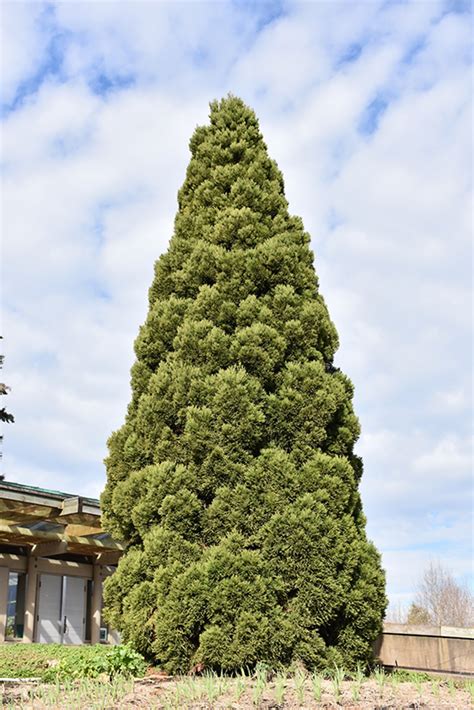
[1,0,472,604]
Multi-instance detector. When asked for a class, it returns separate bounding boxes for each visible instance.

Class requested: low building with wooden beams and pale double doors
[0,481,123,644]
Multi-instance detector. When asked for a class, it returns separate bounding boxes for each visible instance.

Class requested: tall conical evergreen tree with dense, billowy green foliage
[102,96,386,672]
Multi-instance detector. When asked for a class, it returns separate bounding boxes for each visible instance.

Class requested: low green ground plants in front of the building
[0,643,146,681]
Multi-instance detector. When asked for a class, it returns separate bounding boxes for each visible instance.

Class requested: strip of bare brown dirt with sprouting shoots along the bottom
[0,675,473,710]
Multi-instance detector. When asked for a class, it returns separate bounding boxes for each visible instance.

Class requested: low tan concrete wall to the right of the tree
[375,623,474,673]
